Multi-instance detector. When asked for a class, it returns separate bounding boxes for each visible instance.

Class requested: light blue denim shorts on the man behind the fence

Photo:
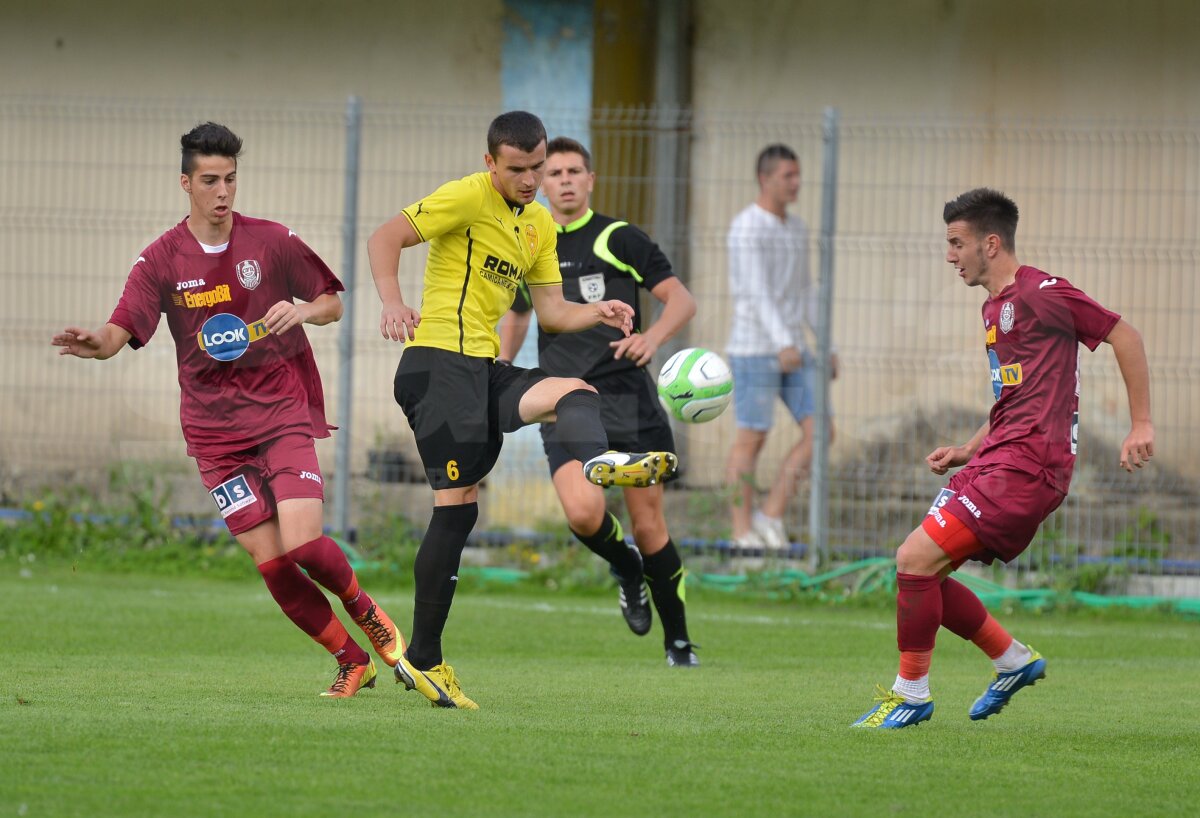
[730,351,817,432]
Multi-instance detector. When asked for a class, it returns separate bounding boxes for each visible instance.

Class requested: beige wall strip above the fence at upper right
[695,0,1200,120]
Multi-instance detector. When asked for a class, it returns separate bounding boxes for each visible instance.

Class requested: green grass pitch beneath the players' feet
[0,563,1200,818]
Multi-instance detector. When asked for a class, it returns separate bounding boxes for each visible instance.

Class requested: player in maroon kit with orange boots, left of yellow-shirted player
[52,122,404,698]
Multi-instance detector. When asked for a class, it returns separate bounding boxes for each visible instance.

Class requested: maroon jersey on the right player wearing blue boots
[971,266,1121,493]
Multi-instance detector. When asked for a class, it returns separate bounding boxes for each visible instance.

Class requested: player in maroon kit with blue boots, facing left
[854,188,1154,729]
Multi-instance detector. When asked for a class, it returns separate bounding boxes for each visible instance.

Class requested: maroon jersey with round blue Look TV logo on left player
[109,213,343,456]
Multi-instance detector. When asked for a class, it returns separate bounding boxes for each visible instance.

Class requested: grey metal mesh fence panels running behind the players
[0,98,1200,595]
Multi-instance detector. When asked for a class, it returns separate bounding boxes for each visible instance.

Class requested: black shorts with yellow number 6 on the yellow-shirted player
[394,347,547,489]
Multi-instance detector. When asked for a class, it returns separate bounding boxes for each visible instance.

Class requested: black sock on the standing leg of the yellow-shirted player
[406,503,479,670]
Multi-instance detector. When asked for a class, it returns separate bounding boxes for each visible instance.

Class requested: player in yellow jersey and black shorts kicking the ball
[367,110,677,710]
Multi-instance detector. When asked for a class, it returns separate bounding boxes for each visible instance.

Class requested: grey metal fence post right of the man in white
[809,108,840,567]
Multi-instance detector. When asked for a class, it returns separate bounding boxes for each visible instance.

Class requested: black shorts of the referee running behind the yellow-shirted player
[541,368,674,475]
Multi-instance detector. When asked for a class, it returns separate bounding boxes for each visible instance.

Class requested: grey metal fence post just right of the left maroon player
[334,96,362,536]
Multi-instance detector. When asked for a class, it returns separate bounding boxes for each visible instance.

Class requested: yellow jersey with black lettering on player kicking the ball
[402,172,563,357]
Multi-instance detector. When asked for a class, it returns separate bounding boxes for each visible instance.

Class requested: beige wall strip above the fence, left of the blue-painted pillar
[0,0,504,104]
